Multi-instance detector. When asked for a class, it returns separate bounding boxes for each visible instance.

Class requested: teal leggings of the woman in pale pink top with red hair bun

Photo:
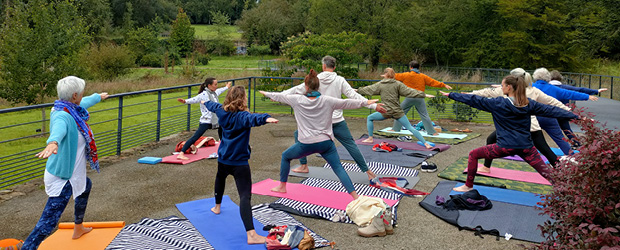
[280,140,355,193]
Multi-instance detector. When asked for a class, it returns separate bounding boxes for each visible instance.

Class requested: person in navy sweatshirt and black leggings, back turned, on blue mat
[202,86,278,244]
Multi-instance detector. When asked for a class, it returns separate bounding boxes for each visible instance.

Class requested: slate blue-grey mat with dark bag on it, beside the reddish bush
[420,181,551,242]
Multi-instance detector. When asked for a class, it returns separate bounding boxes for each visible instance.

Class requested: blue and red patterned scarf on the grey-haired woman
[54,100,99,173]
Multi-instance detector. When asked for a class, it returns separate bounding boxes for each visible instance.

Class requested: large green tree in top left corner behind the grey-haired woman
[0,0,89,104]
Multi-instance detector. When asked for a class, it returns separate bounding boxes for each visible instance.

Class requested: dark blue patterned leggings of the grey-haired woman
[22,177,92,250]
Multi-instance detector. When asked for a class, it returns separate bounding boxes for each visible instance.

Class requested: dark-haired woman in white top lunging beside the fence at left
[177,77,232,160]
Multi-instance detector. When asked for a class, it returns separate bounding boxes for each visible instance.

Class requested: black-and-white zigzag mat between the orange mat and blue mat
[106,216,213,250]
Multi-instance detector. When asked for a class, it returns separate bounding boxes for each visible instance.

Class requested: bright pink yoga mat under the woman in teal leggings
[252,179,398,210]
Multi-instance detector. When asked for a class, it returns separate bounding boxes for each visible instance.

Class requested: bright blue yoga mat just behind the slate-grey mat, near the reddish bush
[446,183,542,207]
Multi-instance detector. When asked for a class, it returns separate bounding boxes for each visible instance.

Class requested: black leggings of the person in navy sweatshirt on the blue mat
[215,161,254,231]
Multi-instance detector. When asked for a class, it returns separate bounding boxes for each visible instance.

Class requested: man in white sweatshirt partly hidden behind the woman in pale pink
[282,56,386,179]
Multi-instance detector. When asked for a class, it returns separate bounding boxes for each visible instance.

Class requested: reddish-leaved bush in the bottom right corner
[533,109,620,249]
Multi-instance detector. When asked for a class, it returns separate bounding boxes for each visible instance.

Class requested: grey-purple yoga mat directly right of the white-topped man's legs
[336,145,437,167]
